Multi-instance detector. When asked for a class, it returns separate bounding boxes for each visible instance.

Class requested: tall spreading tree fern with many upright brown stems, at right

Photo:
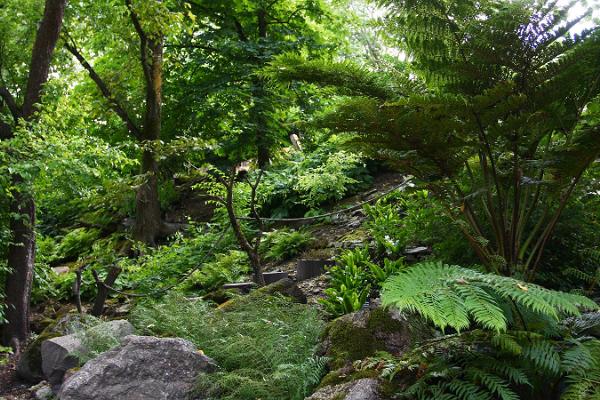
[270,0,600,279]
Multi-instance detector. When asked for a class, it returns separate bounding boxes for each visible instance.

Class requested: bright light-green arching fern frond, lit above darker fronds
[382,262,598,332]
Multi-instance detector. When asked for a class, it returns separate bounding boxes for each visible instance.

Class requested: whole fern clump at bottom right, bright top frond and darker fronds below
[382,261,600,400]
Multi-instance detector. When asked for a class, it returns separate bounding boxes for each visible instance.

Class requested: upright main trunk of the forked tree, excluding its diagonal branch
[134,38,163,244]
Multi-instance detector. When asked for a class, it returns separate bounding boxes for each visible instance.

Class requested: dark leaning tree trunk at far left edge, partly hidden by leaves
[2,0,67,351]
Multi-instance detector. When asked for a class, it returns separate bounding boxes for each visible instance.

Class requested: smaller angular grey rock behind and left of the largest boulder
[41,320,135,387]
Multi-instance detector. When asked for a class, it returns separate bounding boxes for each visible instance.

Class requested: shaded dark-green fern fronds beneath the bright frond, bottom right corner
[386,330,600,400]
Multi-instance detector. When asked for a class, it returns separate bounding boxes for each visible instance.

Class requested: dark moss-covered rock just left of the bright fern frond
[323,307,413,369]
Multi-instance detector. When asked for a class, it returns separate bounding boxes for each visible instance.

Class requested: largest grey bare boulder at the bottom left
[58,335,216,400]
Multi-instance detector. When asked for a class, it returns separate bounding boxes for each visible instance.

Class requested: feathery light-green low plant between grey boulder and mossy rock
[131,294,325,400]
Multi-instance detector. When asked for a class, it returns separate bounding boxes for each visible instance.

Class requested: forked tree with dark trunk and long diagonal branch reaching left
[65,0,180,245]
